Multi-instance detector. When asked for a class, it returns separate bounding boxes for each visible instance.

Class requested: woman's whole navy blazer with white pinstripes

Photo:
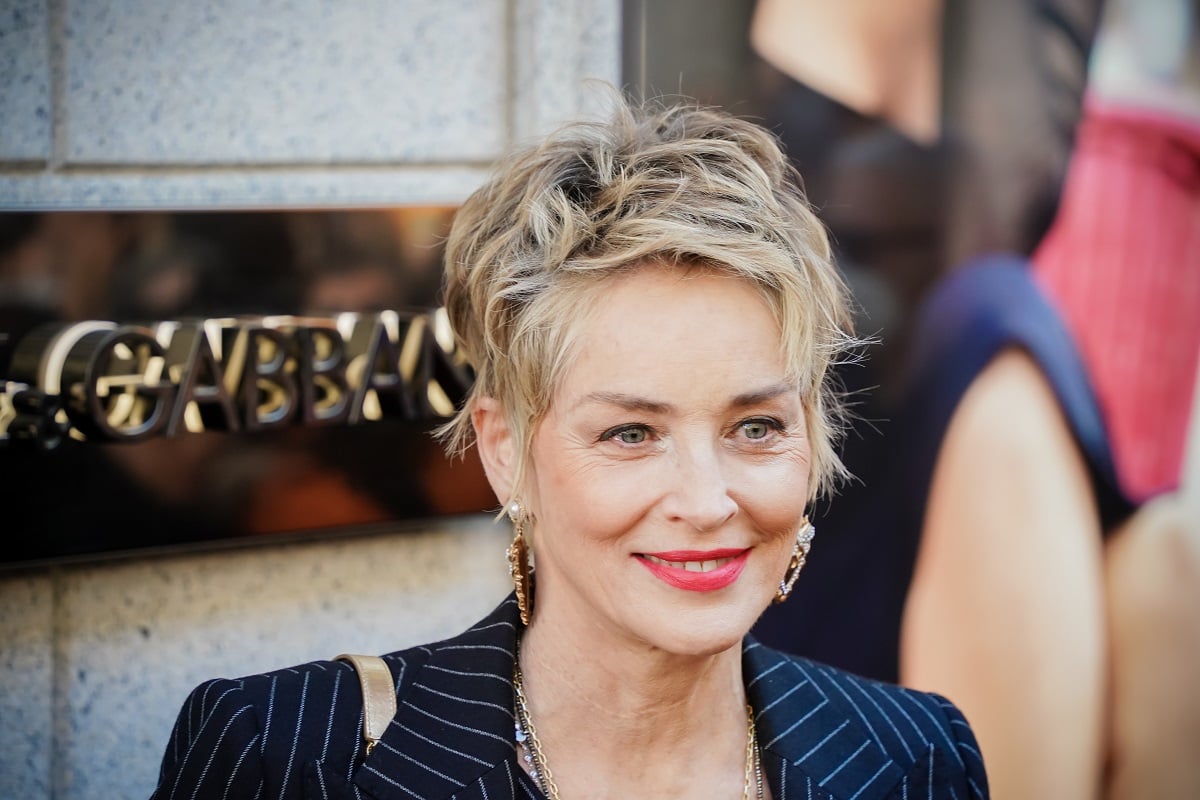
[152,596,988,800]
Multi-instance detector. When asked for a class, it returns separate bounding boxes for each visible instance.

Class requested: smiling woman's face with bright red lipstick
[524,265,809,655]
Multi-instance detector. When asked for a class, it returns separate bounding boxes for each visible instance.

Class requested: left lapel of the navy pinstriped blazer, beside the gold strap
[354,597,518,800]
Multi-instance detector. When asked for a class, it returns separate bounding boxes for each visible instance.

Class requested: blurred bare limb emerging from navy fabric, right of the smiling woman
[900,350,1106,800]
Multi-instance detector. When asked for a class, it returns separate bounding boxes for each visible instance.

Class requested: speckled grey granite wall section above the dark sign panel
[0,0,619,209]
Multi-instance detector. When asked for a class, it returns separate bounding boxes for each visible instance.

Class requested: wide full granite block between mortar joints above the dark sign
[64,0,506,164]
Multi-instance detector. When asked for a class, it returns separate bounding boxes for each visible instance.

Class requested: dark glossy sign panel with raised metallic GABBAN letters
[0,207,496,566]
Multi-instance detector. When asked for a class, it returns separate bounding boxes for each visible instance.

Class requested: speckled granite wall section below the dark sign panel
[0,516,510,800]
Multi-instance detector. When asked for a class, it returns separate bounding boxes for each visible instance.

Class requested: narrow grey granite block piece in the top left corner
[0,0,53,162]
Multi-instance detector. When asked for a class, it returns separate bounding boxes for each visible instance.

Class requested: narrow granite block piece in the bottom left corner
[0,575,55,800]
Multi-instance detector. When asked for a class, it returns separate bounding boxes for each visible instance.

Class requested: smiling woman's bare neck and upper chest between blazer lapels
[520,599,746,800]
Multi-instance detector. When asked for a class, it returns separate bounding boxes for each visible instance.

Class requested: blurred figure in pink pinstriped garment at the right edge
[1034,0,1200,798]
